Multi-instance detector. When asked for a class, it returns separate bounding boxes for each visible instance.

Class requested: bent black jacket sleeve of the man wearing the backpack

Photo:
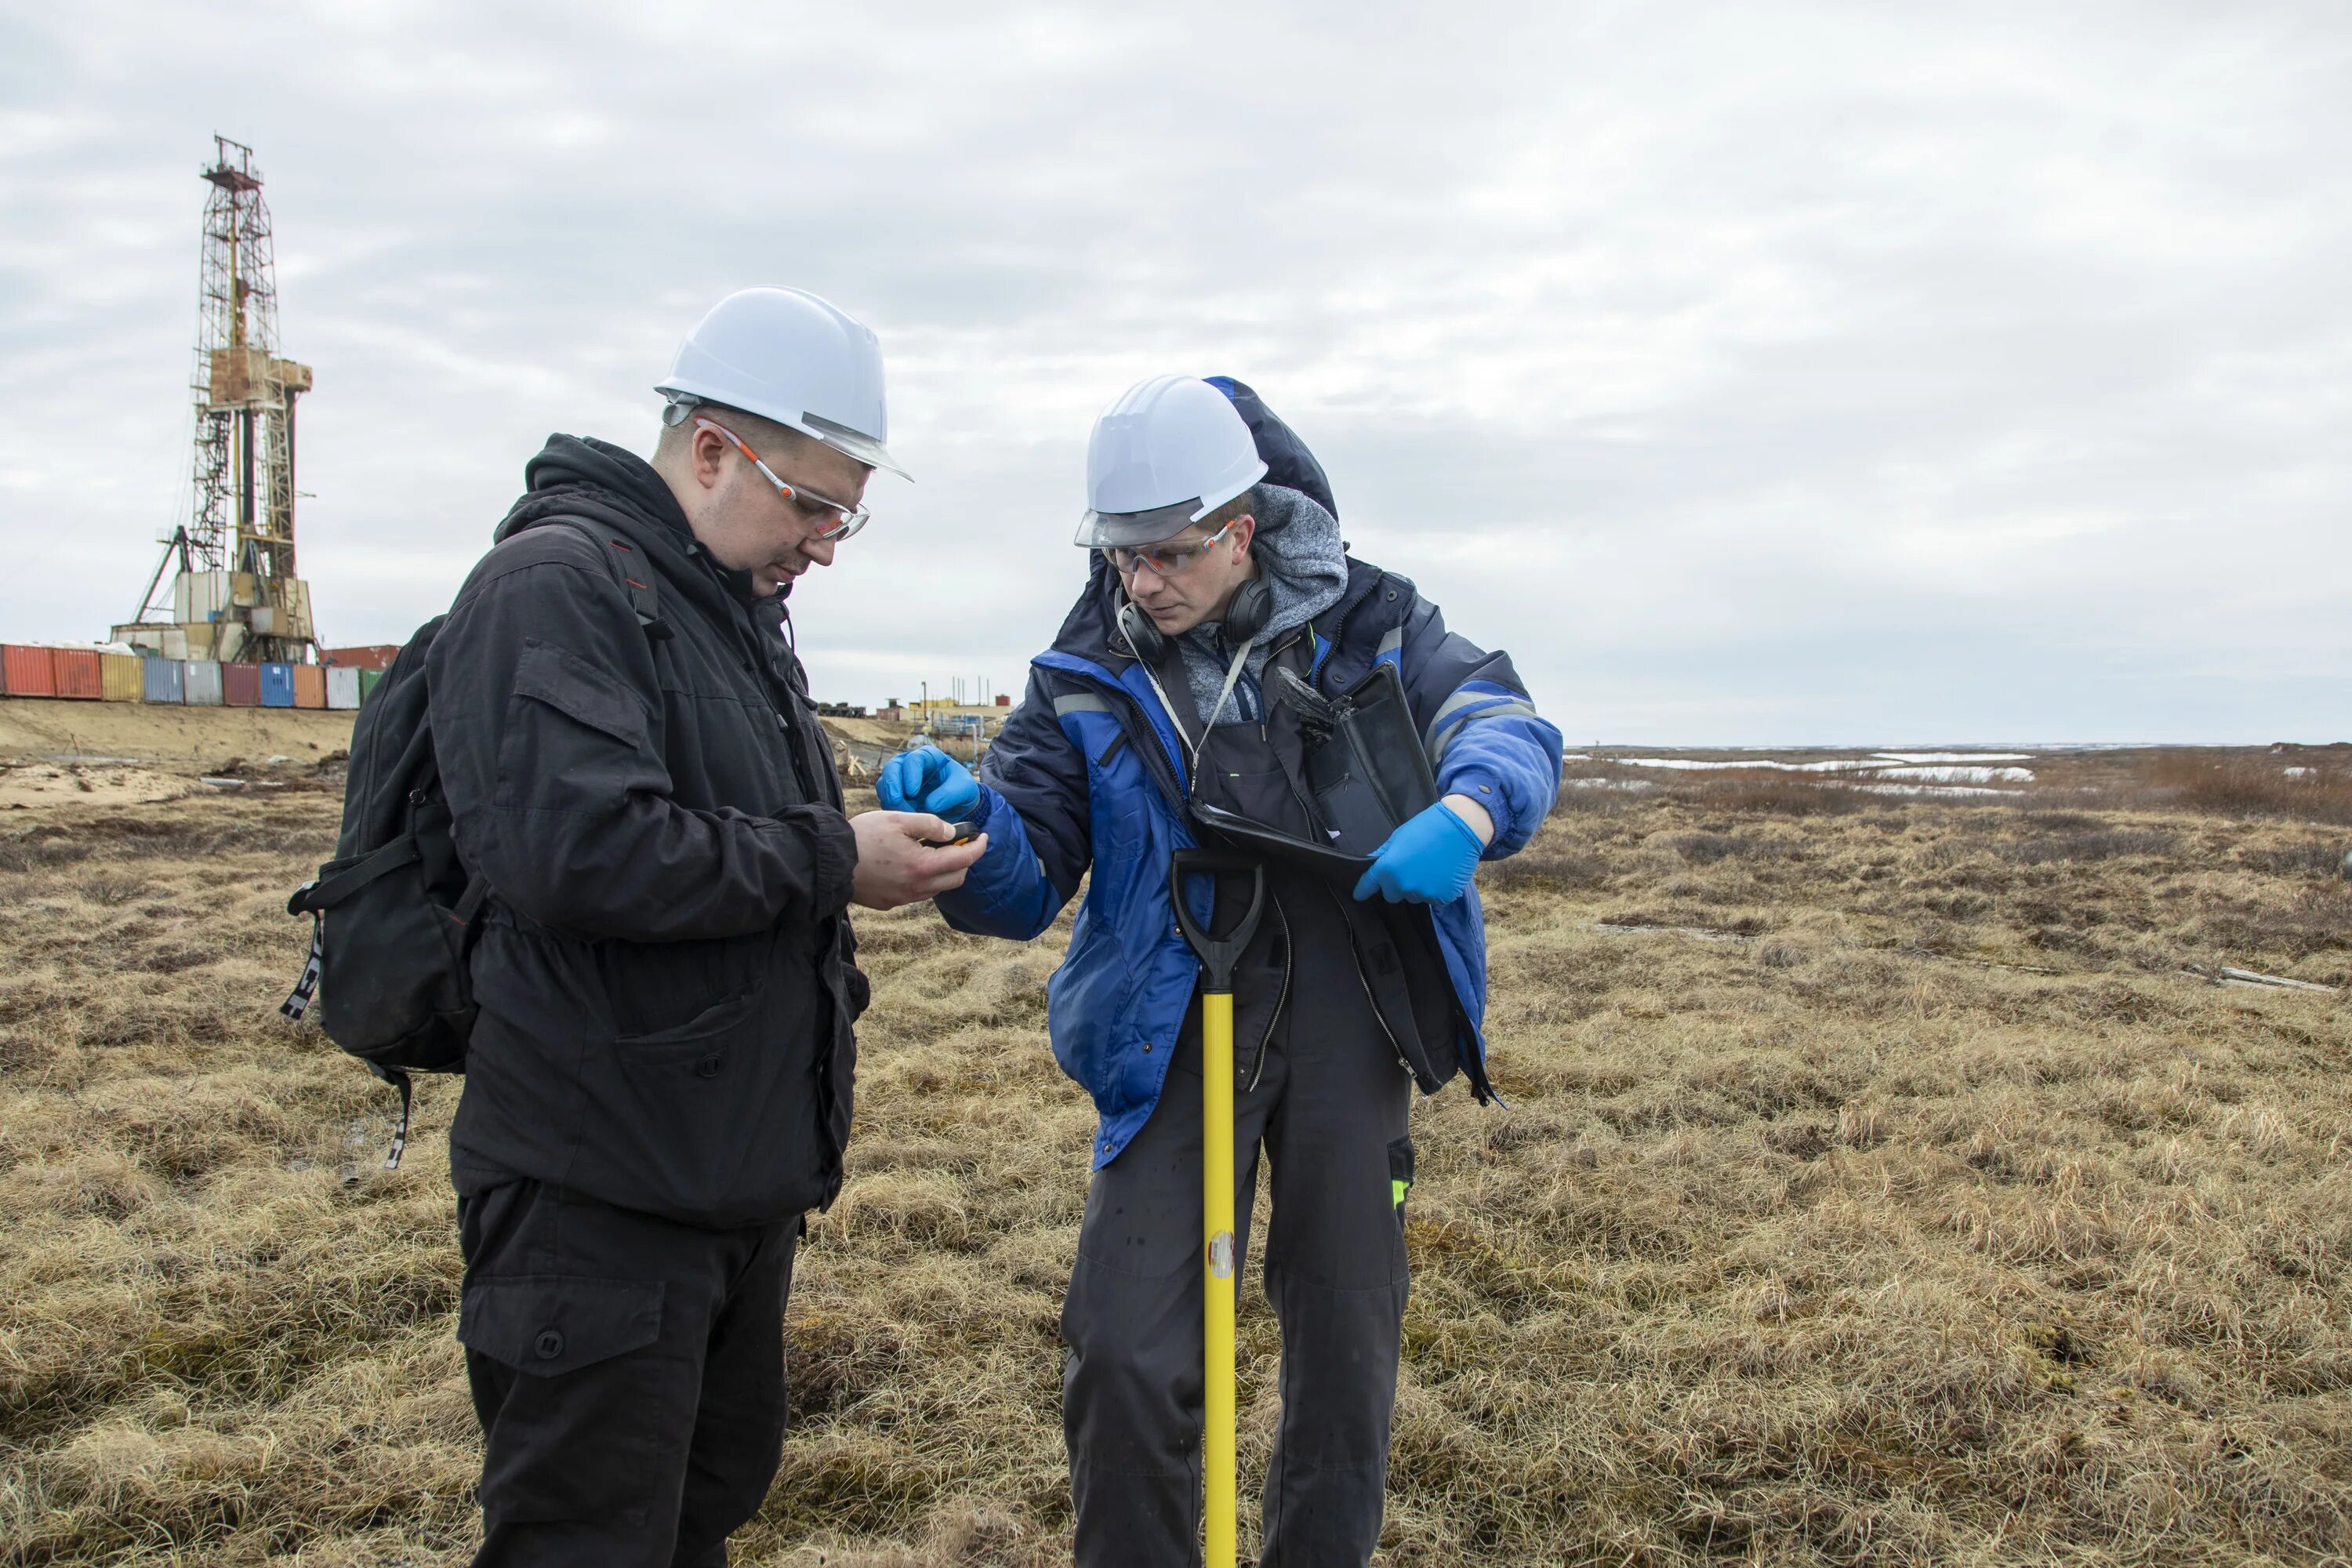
[426,529,856,942]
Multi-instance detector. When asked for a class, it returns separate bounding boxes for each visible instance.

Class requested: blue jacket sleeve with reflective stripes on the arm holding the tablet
[1399,600,1562,860]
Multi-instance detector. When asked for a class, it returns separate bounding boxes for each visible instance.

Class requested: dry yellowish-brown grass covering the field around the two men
[0,760,2352,1568]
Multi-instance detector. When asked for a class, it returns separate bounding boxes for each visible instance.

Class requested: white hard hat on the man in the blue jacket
[1077,376,1265,550]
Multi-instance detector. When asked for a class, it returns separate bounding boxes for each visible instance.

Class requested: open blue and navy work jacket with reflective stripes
[938,555,1559,1168]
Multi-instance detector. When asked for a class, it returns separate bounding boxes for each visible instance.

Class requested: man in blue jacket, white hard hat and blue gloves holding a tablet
[880,376,1559,1568]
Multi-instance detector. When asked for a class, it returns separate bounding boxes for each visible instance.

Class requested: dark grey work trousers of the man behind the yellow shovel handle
[1061,945,1414,1568]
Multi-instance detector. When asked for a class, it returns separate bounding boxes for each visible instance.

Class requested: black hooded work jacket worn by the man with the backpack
[426,435,868,1227]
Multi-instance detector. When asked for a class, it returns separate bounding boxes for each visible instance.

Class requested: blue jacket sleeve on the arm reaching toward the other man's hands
[934,670,1094,942]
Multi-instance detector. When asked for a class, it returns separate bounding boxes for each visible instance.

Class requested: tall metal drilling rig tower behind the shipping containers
[136,136,313,661]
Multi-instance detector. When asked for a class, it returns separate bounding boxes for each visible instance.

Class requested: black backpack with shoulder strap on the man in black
[278,517,670,1171]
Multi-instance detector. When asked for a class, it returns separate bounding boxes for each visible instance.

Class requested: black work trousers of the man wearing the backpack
[456,1180,802,1568]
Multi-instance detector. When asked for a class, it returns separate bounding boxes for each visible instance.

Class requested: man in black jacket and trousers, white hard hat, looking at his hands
[428,289,985,1568]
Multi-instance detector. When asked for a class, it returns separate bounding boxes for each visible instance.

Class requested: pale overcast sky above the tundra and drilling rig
[0,0,2352,746]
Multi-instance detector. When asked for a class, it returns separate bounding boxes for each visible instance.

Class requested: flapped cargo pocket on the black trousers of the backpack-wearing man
[456,1274,673,1526]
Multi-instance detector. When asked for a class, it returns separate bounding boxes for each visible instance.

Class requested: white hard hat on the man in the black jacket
[654,289,910,477]
